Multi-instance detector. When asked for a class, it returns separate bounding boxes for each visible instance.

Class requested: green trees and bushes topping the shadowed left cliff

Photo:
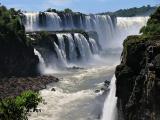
[0,6,26,42]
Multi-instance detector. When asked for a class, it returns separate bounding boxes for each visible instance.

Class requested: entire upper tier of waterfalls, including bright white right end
[23,12,148,49]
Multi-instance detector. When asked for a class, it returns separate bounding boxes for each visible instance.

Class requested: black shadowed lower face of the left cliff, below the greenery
[0,35,39,77]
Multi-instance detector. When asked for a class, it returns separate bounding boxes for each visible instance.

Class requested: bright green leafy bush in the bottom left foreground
[0,91,42,120]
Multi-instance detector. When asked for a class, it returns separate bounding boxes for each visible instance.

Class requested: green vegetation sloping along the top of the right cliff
[123,7,160,53]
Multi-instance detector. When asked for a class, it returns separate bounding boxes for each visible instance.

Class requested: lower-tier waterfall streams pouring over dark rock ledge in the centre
[36,33,99,69]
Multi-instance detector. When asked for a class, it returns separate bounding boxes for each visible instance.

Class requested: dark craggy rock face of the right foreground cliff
[116,36,160,120]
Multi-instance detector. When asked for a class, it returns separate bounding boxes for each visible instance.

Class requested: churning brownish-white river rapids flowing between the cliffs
[29,52,120,120]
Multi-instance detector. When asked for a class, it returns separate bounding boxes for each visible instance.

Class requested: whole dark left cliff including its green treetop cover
[0,6,39,77]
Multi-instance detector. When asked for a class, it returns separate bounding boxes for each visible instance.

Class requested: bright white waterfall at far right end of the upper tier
[108,17,149,48]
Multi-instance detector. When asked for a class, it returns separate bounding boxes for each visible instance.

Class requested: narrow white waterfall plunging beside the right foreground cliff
[101,76,117,120]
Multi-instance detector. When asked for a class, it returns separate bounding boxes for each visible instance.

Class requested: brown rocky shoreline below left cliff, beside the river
[0,75,59,99]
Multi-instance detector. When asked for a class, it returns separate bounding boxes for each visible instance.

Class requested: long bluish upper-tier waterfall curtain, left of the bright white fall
[23,12,115,47]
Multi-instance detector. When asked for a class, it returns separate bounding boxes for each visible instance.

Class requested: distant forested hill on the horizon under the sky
[101,5,157,17]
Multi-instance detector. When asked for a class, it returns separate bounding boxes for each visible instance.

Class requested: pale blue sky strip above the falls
[0,0,160,13]
